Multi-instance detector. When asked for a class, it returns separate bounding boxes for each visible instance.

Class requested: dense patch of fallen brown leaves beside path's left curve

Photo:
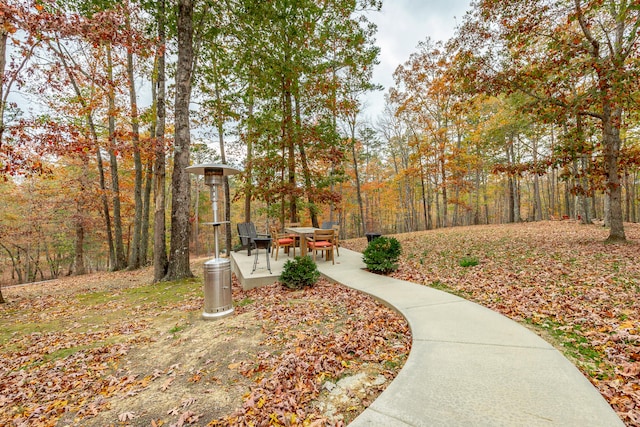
[214,280,410,425]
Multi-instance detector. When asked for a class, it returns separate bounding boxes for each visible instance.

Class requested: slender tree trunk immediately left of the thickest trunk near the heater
[153,0,168,282]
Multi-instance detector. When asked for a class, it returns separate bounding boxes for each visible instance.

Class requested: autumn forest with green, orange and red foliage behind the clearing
[0,0,640,295]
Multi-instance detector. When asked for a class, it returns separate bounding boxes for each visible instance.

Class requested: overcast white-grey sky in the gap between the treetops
[364,0,470,121]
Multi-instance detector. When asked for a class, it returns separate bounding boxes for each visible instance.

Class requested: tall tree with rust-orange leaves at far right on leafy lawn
[458,0,640,241]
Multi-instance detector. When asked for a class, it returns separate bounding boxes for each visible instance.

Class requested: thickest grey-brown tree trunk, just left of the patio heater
[165,0,193,280]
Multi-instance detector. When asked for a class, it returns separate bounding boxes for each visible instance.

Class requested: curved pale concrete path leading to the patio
[318,248,624,427]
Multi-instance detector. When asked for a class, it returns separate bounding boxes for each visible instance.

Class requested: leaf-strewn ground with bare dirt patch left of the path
[0,261,411,426]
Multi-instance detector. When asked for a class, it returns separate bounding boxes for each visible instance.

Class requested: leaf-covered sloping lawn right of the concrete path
[344,221,640,426]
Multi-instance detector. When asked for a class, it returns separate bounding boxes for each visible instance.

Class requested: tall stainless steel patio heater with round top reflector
[186,163,241,320]
